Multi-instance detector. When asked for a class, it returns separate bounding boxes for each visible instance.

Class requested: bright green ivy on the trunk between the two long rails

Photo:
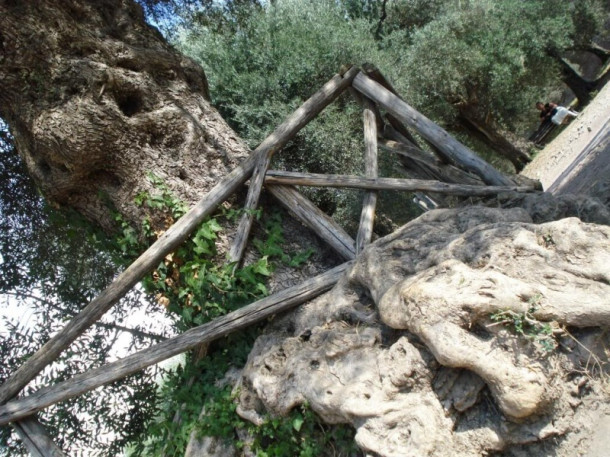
[115,175,313,329]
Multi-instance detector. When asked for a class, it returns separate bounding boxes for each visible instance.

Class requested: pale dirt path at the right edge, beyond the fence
[522,84,610,204]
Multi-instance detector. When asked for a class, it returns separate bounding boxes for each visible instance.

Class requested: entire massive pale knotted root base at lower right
[239,204,610,457]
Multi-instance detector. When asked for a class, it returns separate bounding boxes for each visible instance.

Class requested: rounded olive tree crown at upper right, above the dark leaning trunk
[405,0,575,129]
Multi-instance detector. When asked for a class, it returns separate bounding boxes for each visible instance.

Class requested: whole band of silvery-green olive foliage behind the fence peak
[176,0,606,175]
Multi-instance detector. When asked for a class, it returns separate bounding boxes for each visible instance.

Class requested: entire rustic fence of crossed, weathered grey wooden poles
[0,67,536,457]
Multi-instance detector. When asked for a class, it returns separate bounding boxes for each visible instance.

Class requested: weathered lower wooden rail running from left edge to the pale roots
[0,262,352,425]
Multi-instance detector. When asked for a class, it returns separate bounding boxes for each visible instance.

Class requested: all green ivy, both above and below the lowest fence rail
[116,175,357,457]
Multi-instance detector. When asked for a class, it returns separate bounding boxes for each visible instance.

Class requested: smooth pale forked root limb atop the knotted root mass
[379,219,610,418]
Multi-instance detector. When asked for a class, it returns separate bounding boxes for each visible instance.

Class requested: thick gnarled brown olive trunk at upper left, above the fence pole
[0,0,247,228]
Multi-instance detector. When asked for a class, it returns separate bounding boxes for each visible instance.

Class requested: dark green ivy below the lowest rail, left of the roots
[133,342,360,457]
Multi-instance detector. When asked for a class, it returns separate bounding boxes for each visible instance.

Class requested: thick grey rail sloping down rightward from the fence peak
[352,73,512,186]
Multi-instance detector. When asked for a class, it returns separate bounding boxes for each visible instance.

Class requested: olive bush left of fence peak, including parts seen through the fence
[176,0,418,228]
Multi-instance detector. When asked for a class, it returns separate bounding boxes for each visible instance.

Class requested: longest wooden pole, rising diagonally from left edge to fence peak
[0,68,358,404]
